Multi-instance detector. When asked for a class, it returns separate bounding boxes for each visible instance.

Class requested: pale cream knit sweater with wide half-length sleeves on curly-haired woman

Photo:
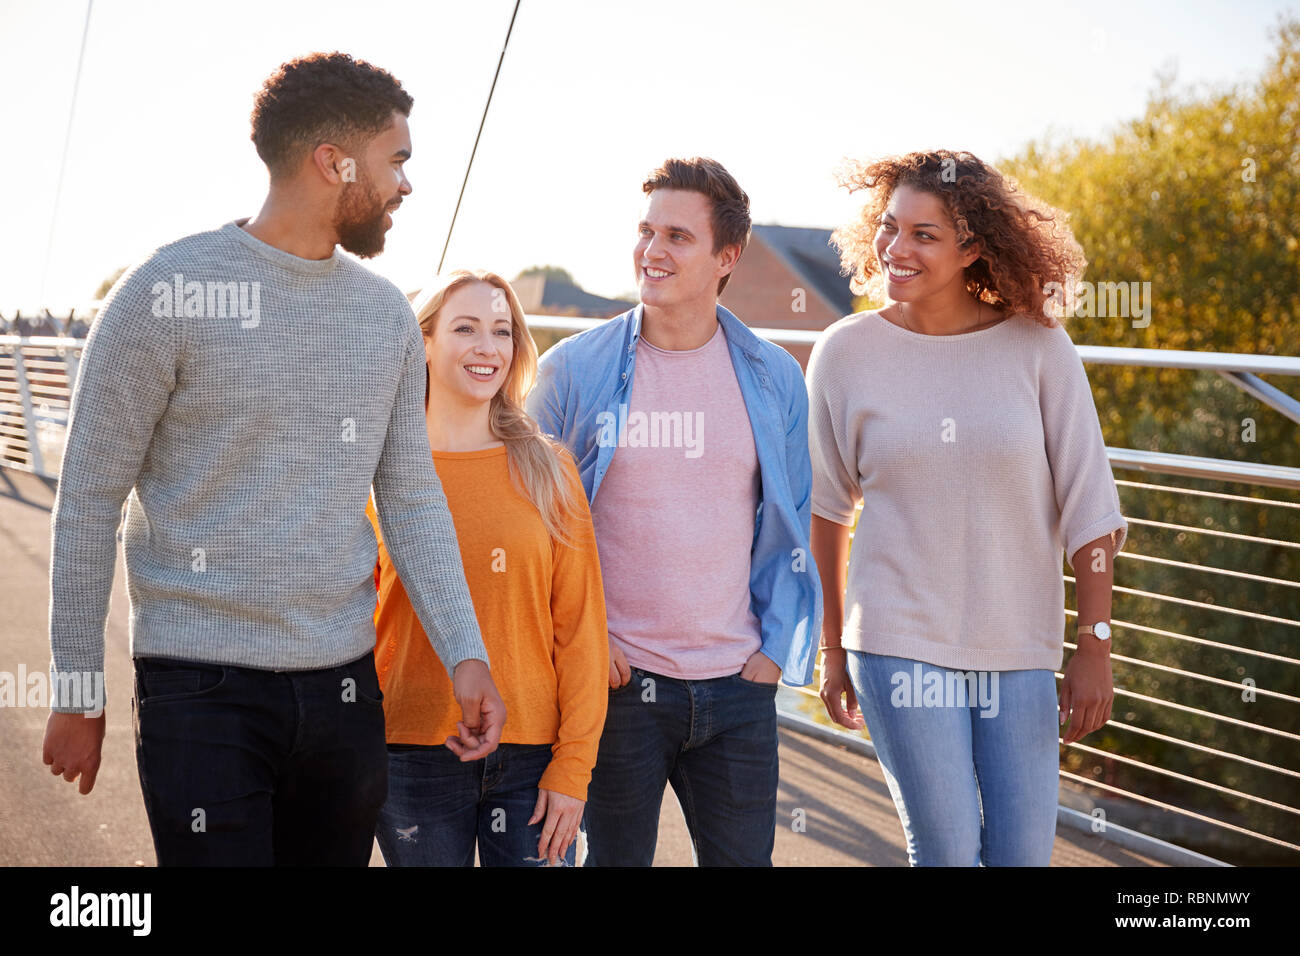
[807,312,1128,670]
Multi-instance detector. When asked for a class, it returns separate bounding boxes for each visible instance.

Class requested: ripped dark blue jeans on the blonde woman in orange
[374,744,577,866]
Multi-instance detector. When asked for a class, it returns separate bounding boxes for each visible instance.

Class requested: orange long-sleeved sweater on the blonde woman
[367,446,610,800]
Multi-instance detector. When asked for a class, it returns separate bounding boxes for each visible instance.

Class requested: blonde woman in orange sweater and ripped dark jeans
[369,271,608,866]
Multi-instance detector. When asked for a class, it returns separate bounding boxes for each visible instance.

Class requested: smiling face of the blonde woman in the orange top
[424,282,515,406]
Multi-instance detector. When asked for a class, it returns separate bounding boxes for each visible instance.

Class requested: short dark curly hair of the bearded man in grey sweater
[252,52,415,176]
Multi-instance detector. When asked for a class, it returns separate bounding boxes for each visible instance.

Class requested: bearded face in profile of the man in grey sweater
[334,111,411,259]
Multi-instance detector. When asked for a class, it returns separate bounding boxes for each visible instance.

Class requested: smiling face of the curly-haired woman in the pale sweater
[875,186,979,302]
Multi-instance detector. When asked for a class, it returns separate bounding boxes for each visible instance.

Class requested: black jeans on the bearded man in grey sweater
[131,653,389,866]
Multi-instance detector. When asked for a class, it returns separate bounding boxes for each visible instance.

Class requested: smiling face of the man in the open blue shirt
[632,189,740,316]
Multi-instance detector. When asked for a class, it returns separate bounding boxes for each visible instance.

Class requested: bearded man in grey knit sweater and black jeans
[43,53,506,865]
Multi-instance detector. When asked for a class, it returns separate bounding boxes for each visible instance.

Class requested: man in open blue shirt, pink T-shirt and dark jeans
[528,159,822,866]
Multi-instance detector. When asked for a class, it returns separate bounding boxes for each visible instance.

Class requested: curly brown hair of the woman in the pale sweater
[831,150,1087,326]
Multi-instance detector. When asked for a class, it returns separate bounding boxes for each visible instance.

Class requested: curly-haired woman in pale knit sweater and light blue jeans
[807,151,1127,866]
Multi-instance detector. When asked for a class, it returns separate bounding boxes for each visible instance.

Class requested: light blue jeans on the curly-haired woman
[848,650,1060,866]
